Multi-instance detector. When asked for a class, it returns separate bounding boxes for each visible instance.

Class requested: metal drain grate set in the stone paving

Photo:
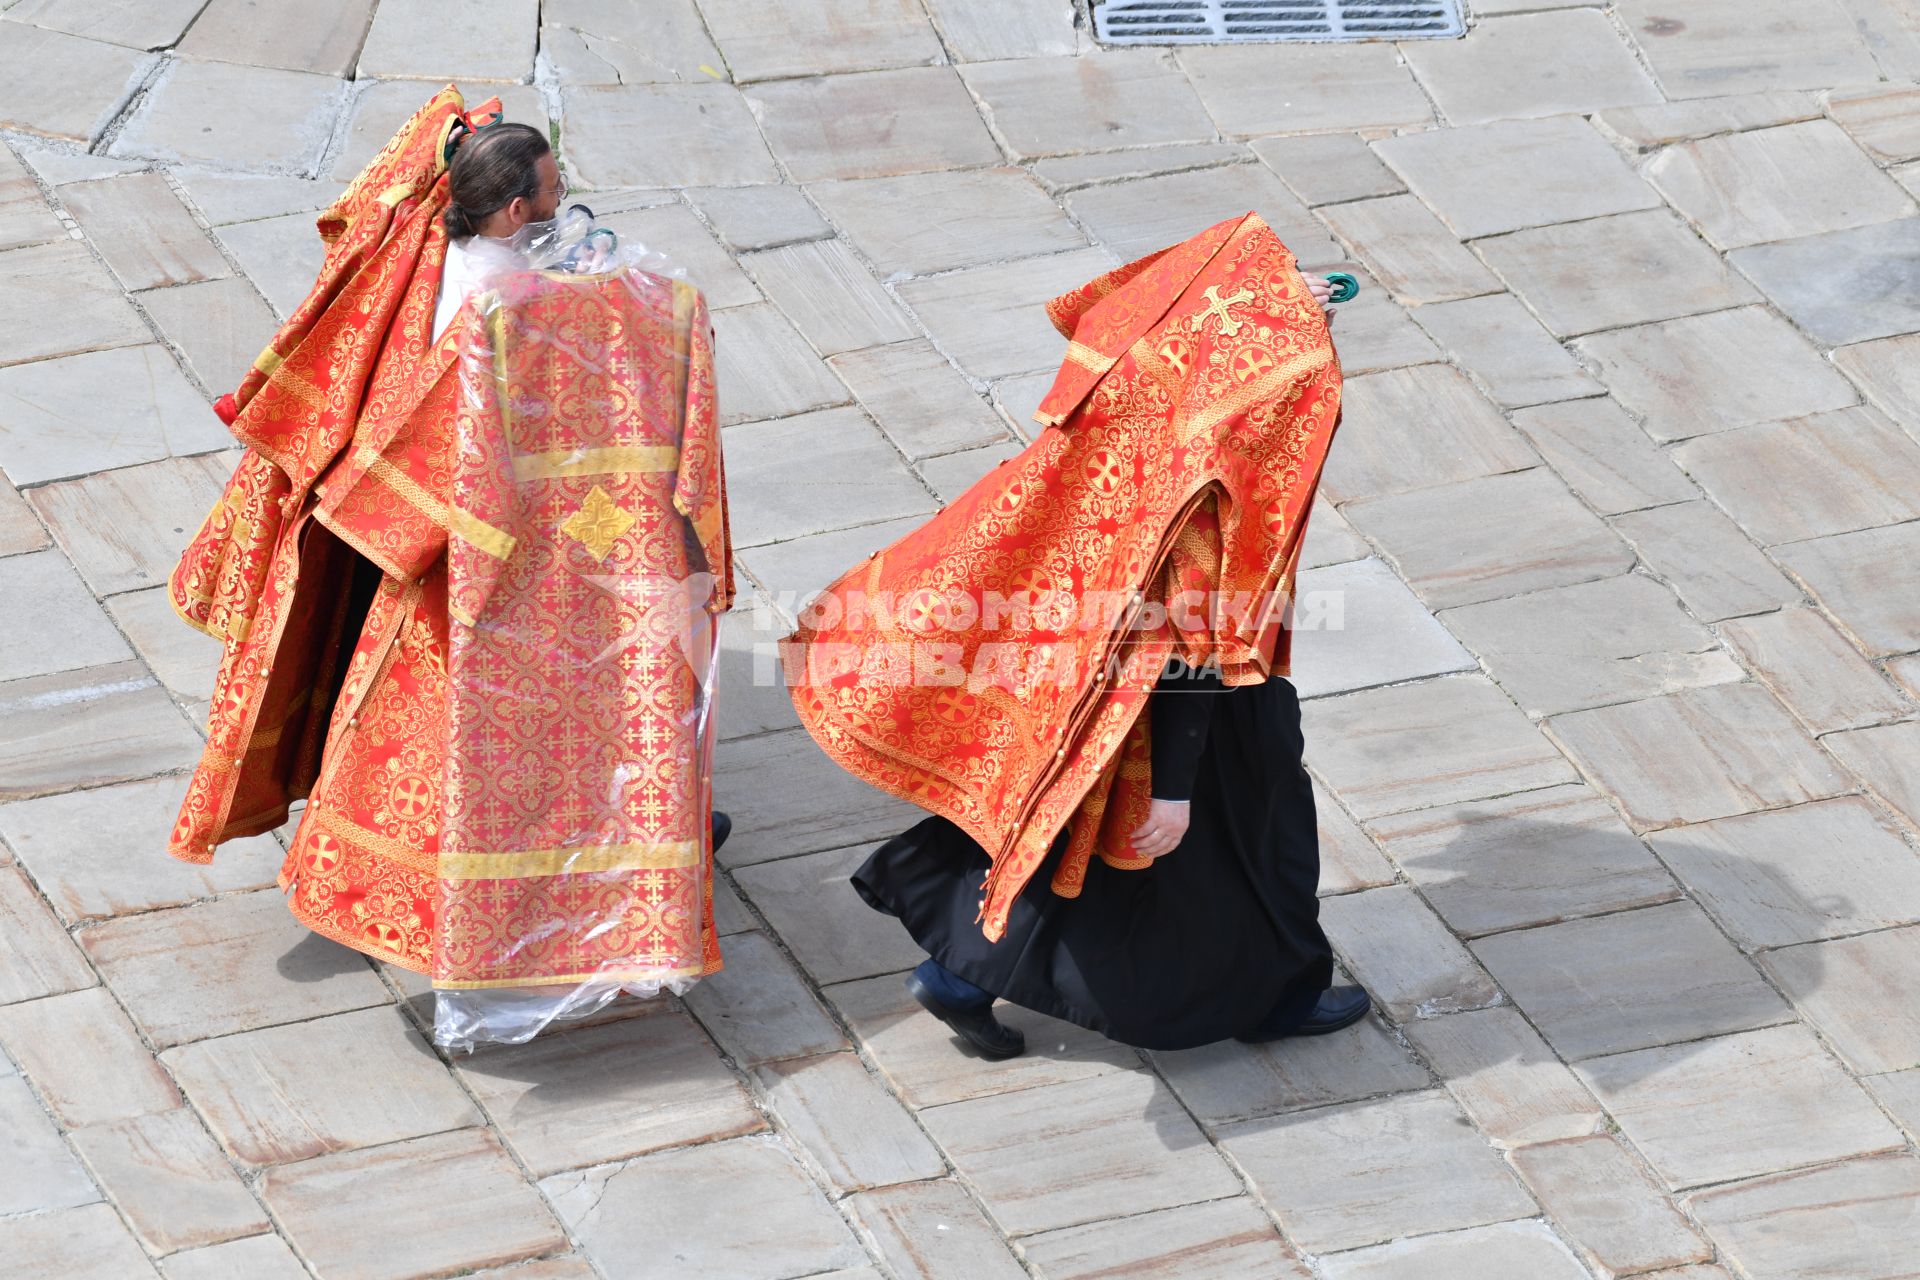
[1092,0,1467,44]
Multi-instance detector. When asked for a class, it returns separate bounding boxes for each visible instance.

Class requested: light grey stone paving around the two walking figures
[0,0,1920,1280]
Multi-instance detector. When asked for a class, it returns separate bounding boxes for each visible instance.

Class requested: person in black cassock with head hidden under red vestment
[785,213,1367,1055]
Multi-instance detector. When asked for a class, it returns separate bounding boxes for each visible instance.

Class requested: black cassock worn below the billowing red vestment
[852,674,1332,1050]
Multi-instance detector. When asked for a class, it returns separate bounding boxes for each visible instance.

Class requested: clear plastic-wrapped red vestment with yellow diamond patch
[434,213,732,1050]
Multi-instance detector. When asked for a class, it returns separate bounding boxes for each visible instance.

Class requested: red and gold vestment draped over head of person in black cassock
[785,213,1340,938]
